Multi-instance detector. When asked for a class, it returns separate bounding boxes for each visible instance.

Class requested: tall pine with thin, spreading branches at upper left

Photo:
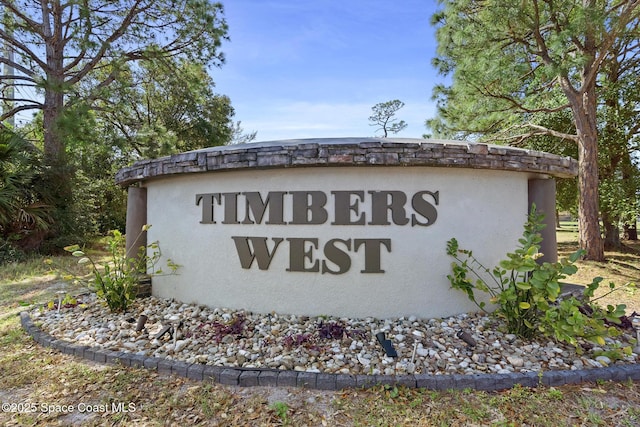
[0,0,227,244]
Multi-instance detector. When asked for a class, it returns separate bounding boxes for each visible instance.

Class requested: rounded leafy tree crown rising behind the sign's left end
[96,60,236,160]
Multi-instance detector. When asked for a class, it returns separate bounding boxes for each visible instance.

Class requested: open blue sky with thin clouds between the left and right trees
[212,0,443,141]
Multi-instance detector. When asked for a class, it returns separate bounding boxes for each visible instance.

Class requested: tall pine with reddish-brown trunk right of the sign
[430,0,640,261]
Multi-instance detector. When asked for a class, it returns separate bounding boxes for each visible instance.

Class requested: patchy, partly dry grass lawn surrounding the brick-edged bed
[0,234,640,427]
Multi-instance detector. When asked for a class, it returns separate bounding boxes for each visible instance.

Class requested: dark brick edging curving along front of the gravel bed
[20,312,640,391]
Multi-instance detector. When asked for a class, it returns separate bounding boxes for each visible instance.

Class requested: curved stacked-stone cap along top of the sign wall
[115,138,578,186]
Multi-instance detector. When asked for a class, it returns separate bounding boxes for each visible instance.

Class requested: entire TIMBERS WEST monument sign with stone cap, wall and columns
[116,138,577,318]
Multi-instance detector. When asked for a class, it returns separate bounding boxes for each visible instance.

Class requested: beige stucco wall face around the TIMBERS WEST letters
[145,167,530,318]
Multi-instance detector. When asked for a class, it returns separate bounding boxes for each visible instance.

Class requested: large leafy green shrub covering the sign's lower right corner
[447,206,626,347]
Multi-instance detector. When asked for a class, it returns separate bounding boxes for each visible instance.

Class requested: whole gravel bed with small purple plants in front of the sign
[29,294,638,375]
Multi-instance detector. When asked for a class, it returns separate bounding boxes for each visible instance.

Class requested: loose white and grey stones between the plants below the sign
[30,298,636,375]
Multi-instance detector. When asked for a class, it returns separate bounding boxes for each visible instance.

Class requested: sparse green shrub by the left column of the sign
[64,225,179,312]
